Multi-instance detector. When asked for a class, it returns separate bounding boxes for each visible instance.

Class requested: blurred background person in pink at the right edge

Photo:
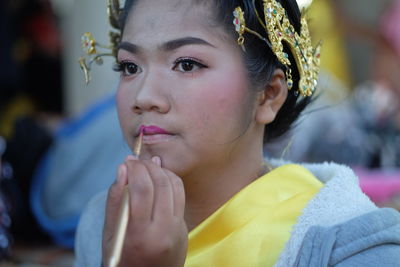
[344,0,400,170]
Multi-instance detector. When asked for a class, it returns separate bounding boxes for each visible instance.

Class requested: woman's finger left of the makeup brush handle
[104,164,128,239]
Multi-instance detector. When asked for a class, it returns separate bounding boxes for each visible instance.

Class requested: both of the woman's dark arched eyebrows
[117,37,215,54]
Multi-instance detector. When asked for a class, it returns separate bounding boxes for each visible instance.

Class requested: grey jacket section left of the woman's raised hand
[75,191,107,267]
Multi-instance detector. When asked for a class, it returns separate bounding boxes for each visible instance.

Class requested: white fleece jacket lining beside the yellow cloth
[276,163,378,267]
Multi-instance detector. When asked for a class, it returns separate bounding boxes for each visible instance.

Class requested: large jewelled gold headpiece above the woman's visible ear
[233,0,321,96]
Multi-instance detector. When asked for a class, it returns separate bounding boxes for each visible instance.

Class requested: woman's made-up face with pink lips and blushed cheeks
[117,0,261,177]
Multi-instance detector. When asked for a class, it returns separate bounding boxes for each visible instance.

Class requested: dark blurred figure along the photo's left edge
[0,0,63,251]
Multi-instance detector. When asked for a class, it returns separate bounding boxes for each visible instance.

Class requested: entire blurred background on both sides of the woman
[0,0,400,266]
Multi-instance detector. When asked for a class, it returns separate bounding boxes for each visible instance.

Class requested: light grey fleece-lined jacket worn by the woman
[75,162,400,267]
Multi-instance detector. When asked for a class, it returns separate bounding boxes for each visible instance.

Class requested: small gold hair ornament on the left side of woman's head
[78,0,121,84]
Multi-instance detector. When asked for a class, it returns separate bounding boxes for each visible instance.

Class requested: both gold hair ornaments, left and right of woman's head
[79,0,321,96]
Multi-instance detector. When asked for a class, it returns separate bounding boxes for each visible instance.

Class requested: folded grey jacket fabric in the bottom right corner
[295,208,400,267]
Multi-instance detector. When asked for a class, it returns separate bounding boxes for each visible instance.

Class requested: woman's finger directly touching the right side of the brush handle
[126,160,154,224]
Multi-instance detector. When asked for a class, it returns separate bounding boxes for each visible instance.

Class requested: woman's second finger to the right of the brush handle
[145,161,174,219]
